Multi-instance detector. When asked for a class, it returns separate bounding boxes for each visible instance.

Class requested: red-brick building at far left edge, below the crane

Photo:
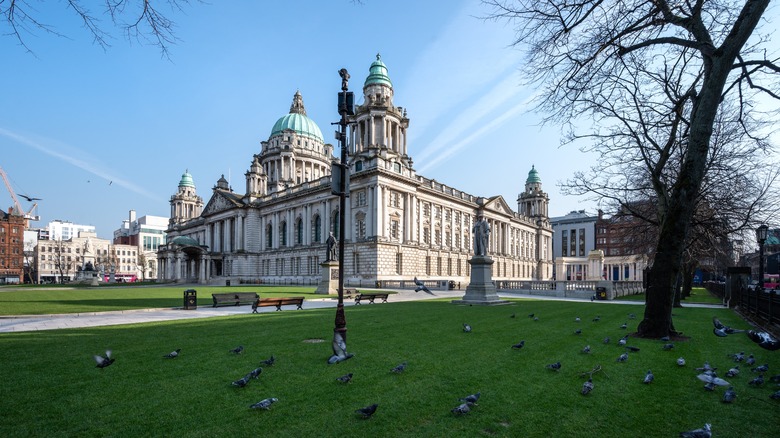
[0,208,25,284]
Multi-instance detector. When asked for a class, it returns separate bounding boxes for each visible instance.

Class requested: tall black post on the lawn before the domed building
[328,68,355,364]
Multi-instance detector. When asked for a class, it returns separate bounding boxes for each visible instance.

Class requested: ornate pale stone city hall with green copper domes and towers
[157,55,553,287]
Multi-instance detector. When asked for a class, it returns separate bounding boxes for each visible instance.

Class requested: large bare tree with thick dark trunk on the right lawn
[486,0,780,337]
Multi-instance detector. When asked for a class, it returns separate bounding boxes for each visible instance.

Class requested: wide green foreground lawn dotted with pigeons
[0,292,780,437]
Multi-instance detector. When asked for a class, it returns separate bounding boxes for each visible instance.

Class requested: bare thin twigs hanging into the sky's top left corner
[0,0,200,57]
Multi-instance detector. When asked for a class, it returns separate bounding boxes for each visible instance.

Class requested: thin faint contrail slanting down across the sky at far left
[0,127,165,201]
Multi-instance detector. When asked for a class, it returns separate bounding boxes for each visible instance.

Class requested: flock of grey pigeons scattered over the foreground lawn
[94,308,780,438]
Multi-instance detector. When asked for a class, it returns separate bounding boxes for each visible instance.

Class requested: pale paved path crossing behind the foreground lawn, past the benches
[0,290,723,333]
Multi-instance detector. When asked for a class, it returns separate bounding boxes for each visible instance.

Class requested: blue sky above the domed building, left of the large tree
[6,0,764,238]
